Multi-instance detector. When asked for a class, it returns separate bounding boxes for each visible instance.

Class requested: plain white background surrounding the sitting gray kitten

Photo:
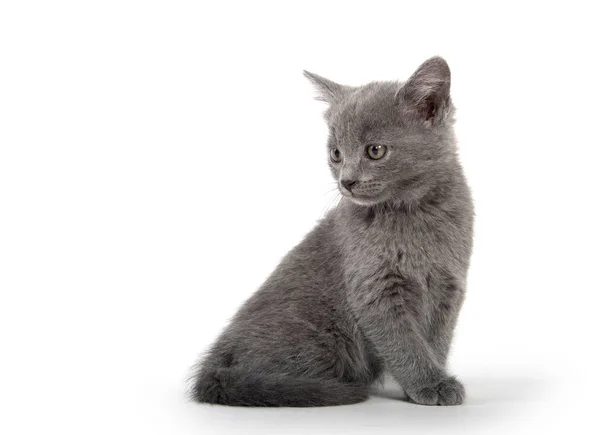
[0,0,600,434]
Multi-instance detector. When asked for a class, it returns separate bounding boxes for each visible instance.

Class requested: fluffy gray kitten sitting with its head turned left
[190,57,473,406]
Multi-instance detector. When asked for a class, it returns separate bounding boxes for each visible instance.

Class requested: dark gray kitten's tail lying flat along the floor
[190,368,368,407]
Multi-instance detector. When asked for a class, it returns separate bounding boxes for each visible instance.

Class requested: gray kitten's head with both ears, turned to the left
[304,57,455,205]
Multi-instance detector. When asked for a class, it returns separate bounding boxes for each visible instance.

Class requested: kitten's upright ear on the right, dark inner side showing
[398,57,450,124]
